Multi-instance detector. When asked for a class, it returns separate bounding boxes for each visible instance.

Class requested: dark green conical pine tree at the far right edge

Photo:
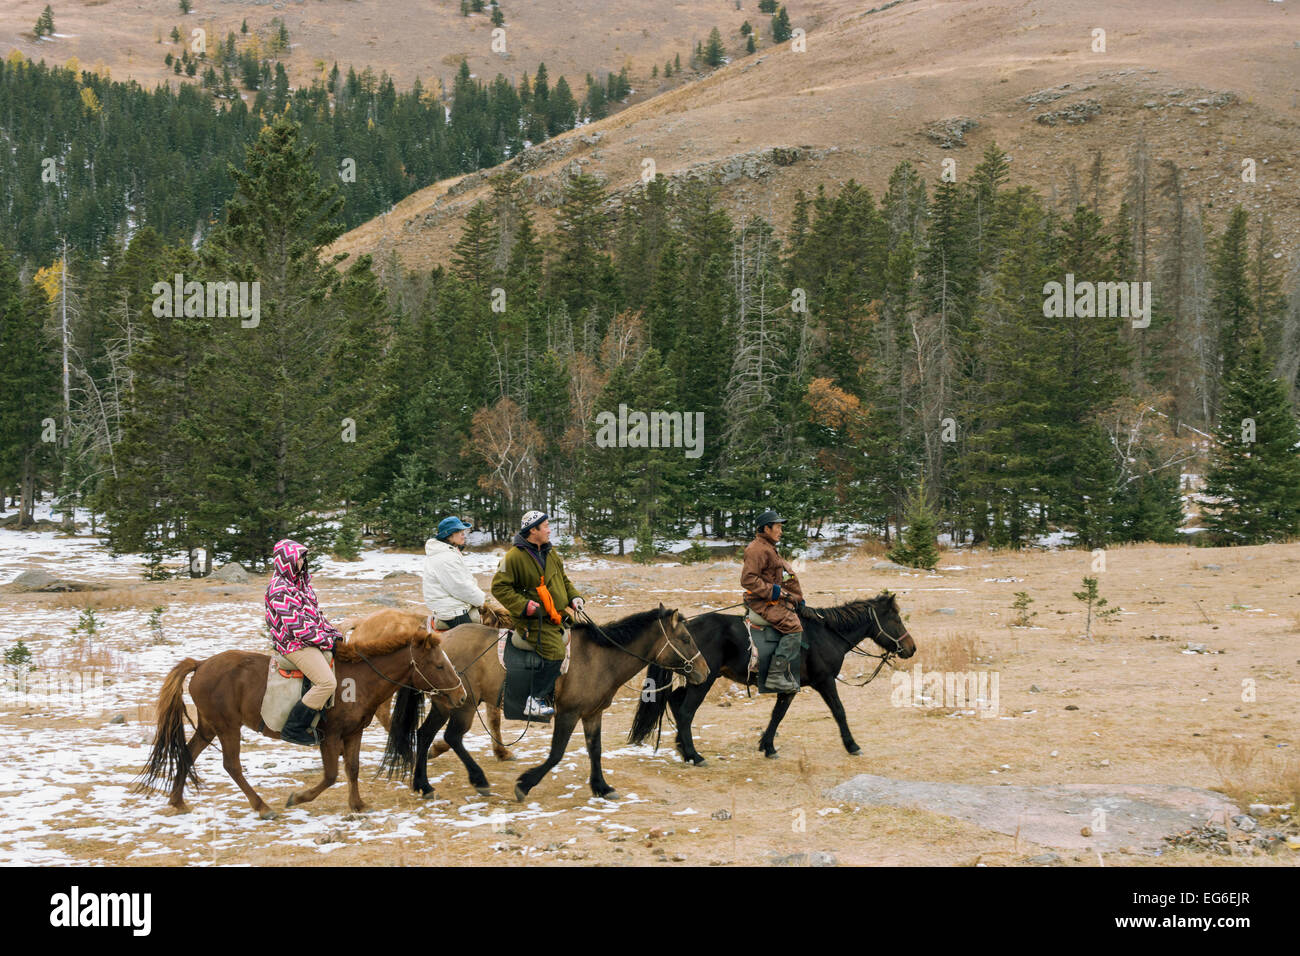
[1203,333,1300,545]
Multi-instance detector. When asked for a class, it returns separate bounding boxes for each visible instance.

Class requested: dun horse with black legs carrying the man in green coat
[385,605,709,800]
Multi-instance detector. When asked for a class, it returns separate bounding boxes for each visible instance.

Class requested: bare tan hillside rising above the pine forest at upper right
[335,0,1300,268]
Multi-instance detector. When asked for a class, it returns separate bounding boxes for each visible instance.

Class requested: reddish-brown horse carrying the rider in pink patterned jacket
[135,610,465,819]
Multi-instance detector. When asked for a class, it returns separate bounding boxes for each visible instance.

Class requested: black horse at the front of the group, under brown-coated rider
[628,591,917,766]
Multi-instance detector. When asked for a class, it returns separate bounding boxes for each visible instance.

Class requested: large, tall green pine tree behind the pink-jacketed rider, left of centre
[195,117,384,563]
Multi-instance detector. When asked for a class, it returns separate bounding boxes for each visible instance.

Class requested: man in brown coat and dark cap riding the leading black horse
[740,510,805,693]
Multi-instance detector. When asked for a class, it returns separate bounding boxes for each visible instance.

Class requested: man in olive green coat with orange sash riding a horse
[491,511,584,717]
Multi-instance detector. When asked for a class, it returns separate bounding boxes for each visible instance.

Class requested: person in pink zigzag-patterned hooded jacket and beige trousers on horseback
[267,538,343,747]
